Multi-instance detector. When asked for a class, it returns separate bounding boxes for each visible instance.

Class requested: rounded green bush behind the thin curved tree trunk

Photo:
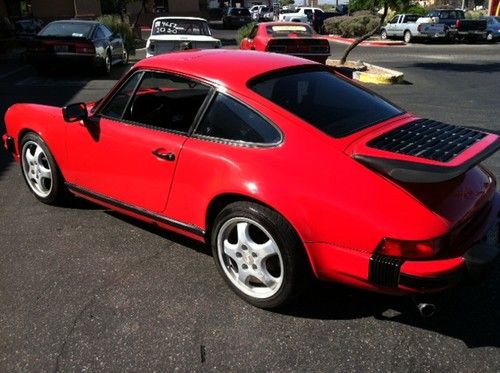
[323,11,380,38]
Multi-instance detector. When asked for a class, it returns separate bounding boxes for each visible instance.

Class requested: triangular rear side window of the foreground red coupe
[195,93,281,144]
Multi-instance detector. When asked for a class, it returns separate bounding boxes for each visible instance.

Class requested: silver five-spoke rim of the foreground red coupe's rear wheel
[217,217,283,299]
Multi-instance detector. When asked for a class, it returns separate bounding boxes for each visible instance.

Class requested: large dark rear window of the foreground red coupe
[248,69,402,138]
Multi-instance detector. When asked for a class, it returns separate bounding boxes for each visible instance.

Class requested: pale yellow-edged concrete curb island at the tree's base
[326,58,404,84]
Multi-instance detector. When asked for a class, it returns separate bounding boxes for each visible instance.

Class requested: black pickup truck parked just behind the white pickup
[426,9,486,40]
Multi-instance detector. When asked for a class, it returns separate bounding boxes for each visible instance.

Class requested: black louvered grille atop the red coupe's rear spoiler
[368,119,486,162]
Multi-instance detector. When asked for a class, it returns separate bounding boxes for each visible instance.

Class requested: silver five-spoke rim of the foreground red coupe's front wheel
[22,141,53,198]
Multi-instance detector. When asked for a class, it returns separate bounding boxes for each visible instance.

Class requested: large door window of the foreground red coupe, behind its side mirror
[123,72,210,133]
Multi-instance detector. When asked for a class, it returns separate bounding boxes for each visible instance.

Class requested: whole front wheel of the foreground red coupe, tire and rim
[21,133,68,205]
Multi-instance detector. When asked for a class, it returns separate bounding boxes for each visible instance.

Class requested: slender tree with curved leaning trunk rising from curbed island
[340,0,410,65]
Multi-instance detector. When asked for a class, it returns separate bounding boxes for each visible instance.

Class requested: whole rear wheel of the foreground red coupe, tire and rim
[211,202,309,309]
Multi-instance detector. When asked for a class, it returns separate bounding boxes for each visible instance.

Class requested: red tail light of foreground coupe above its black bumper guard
[377,238,444,259]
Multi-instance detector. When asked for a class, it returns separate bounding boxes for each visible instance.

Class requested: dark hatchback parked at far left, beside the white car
[26,20,128,74]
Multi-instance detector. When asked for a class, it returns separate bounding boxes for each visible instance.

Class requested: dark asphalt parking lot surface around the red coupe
[0,44,500,372]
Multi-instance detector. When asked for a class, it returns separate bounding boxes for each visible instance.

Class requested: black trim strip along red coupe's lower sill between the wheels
[65,183,205,238]
